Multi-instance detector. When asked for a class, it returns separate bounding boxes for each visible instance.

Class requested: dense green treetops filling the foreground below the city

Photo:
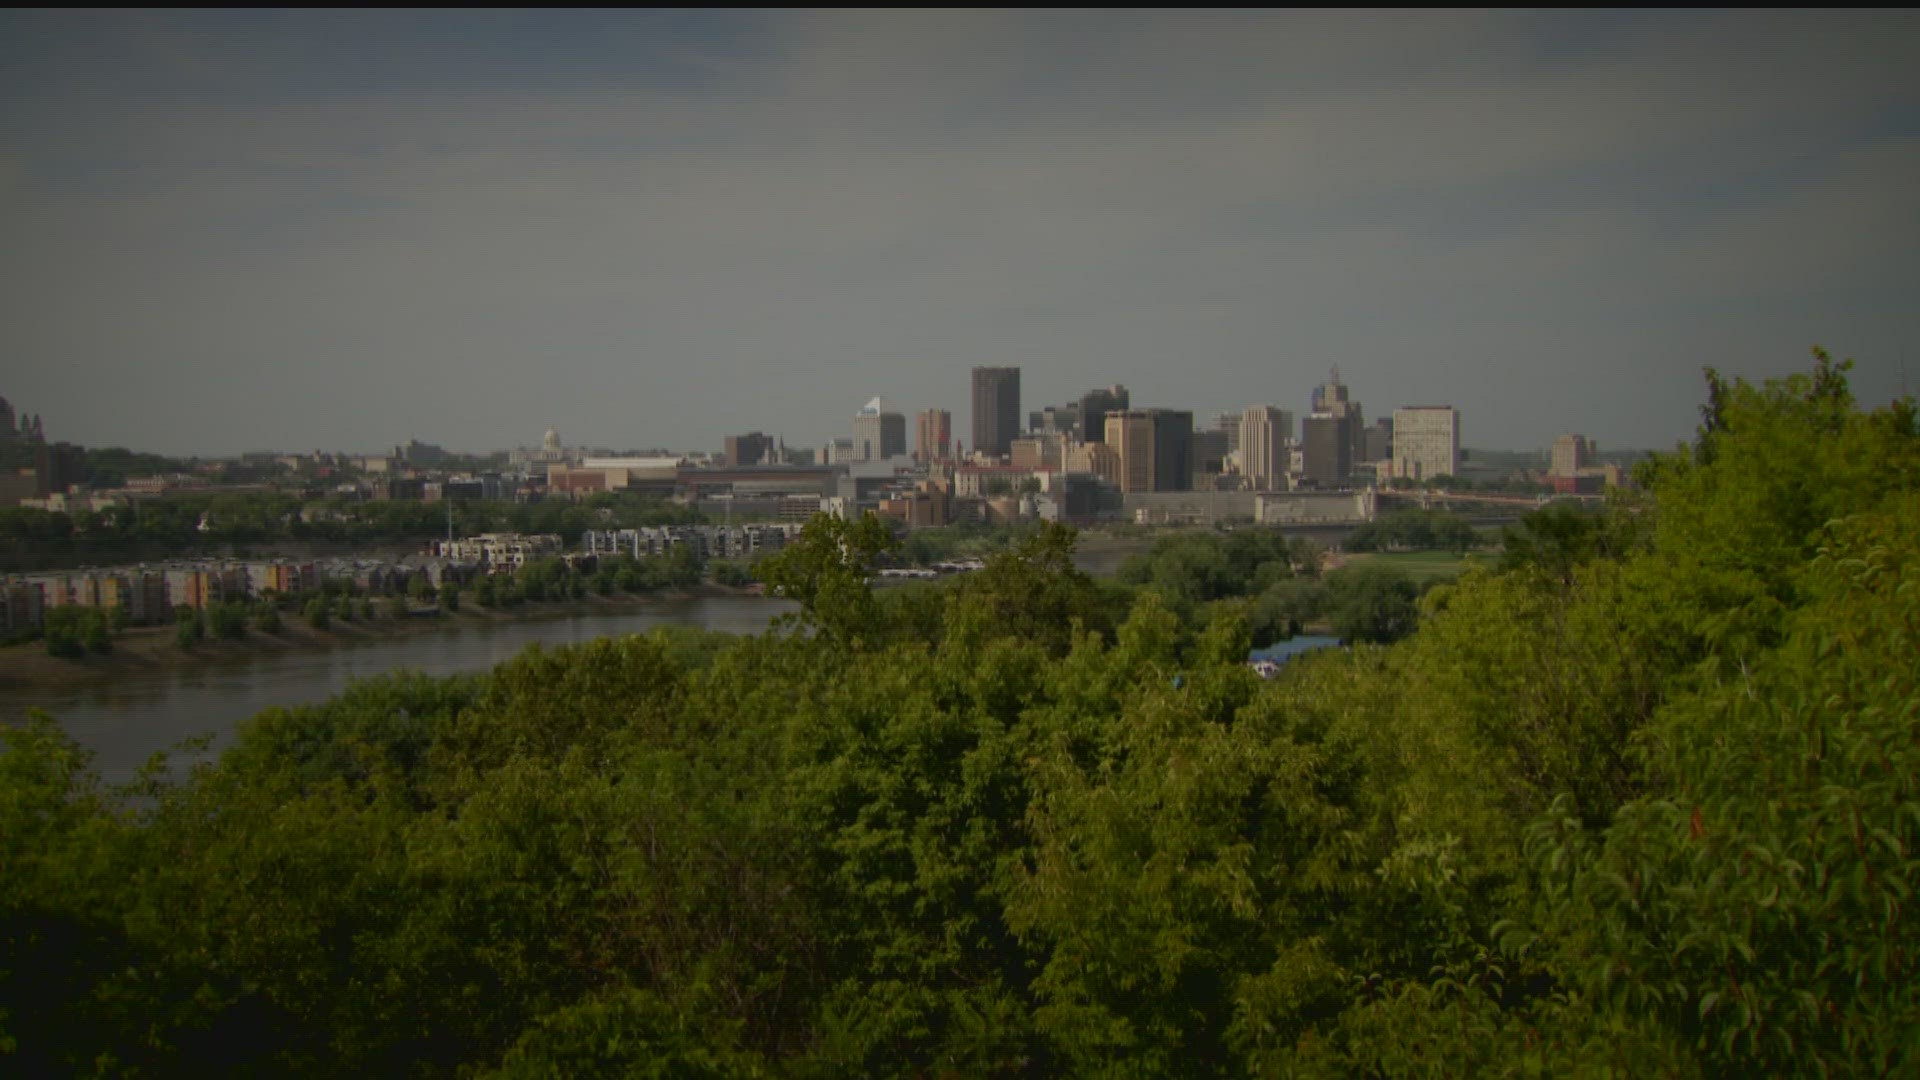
[0,354,1920,1076]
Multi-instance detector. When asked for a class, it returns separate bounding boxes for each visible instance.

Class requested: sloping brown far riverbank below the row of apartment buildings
[0,584,755,690]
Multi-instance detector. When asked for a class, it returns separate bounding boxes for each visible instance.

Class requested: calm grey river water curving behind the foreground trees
[0,596,791,784]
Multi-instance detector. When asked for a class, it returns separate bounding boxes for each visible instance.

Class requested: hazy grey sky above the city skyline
[0,12,1920,454]
